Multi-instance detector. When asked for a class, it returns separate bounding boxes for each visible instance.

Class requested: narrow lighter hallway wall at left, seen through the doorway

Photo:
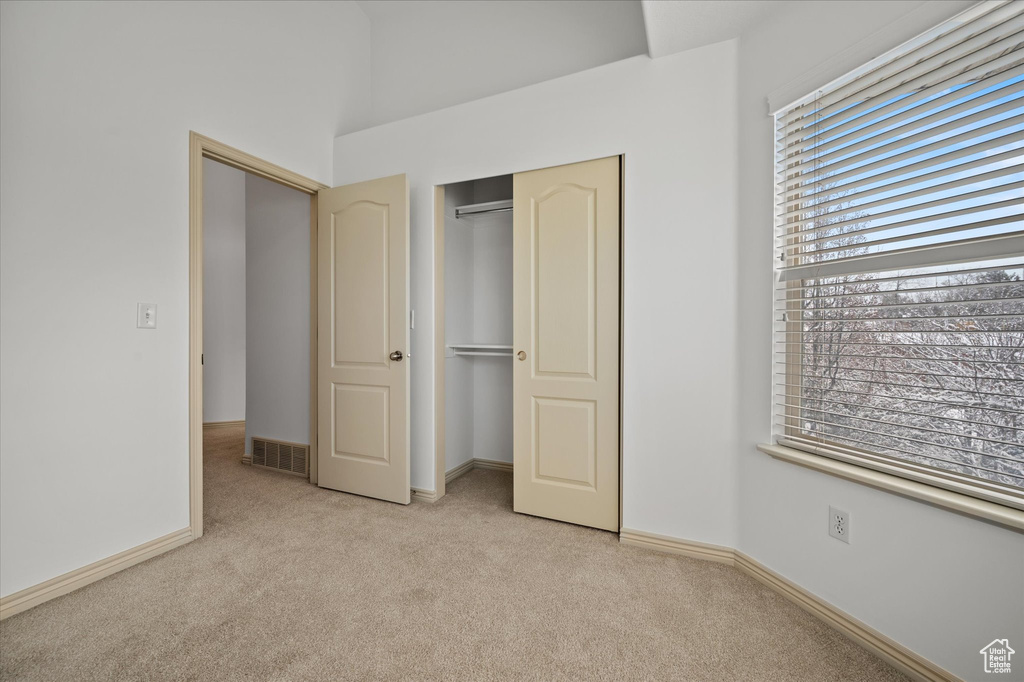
[201,159,246,422]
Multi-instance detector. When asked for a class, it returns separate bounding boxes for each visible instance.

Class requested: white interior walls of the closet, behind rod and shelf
[444,175,512,471]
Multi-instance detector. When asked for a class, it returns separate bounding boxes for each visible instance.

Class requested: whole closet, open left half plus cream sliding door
[436,157,622,530]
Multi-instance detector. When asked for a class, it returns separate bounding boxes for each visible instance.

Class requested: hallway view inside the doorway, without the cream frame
[203,159,311,477]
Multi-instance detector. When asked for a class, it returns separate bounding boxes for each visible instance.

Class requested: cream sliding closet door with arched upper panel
[512,157,620,531]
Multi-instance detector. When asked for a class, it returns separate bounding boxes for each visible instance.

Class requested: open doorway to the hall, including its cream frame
[189,133,325,538]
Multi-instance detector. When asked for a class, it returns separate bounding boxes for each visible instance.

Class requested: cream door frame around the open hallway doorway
[188,130,328,540]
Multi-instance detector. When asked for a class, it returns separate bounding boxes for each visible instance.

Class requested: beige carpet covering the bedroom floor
[0,429,904,682]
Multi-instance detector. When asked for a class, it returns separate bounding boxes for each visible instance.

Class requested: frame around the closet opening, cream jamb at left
[430,153,626,528]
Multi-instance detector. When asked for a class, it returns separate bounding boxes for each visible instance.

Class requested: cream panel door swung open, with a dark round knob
[316,175,410,504]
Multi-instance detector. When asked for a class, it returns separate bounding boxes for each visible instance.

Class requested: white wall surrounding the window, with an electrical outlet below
[737,2,1024,680]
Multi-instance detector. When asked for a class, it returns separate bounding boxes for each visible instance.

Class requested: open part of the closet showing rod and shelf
[435,175,513,501]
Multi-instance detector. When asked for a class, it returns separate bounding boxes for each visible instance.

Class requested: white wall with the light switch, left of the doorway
[0,2,369,595]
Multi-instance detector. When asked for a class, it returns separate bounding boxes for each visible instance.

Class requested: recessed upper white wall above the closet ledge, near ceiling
[359,0,647,124]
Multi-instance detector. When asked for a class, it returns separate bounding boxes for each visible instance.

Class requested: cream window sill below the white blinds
[758,443,1024,531]
